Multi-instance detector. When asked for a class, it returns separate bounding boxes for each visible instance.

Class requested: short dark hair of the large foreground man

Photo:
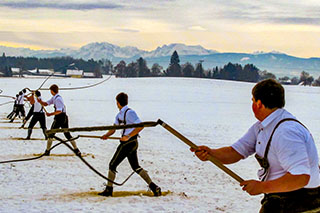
[252,79,285,109]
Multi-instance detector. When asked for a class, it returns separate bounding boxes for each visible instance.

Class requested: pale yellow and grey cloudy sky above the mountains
[0,0,320,57]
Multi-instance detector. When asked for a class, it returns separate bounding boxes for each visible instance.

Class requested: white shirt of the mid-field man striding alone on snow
[114,105,141,135]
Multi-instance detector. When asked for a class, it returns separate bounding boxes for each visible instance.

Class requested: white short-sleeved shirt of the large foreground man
[232,109,320,188]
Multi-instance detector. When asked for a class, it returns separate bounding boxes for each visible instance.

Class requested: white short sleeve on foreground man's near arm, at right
[273,125,311,175]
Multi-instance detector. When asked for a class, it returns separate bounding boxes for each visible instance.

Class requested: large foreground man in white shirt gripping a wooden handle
[191,79,320,213]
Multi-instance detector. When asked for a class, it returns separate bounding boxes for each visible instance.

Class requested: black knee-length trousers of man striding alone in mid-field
[109,136,141,172]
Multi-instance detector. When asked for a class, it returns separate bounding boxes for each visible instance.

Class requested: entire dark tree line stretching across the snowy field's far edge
[0,51,320,86]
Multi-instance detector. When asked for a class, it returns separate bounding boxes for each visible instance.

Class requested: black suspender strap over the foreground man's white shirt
[254,118,307,181]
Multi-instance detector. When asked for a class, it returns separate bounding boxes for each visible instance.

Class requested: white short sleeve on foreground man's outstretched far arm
[231,124,257,158]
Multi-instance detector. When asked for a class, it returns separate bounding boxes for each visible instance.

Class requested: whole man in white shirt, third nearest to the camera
[37,84,81,156]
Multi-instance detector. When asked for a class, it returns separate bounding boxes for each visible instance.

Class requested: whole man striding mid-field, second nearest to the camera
[99,93,161,197]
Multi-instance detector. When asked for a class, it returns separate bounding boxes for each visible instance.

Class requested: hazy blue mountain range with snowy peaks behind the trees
[0,42,320,78]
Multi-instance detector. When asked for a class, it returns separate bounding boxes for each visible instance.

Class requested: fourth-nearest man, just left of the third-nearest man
[26,90,47,140]
